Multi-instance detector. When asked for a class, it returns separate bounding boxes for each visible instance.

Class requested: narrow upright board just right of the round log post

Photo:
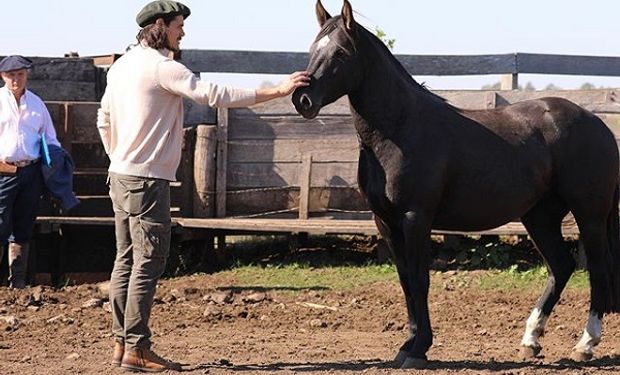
[215,108,228,217]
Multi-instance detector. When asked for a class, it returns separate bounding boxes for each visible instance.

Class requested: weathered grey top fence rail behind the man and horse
[177,50,620,90]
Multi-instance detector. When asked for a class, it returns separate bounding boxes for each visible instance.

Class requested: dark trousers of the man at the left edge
[0,163,43,245]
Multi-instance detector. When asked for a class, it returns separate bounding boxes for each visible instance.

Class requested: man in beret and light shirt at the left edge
[0,56,60,289]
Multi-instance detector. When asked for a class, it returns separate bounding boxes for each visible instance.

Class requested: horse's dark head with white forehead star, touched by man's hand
[293,0,363,119]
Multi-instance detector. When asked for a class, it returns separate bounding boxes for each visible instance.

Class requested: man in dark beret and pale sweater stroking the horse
[97,1,309,372]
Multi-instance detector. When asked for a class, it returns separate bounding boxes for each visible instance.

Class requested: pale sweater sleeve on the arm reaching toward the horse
[157,60,256,108]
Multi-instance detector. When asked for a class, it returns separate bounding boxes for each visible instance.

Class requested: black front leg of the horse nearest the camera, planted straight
[401,211,433,368]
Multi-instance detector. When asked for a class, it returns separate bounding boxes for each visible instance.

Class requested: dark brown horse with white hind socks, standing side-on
[293,0,620,368]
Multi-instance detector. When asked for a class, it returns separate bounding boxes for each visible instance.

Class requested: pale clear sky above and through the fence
[0,0,620,89]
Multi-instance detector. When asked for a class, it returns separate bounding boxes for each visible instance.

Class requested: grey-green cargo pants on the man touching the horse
[109,173,170,349]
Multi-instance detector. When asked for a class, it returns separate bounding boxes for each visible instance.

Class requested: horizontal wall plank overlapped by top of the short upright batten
[228,136,359,163]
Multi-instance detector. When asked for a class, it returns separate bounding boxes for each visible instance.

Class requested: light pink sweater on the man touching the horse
[97,45,256,181]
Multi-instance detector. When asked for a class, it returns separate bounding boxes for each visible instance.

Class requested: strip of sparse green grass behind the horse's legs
[216,263,589,292]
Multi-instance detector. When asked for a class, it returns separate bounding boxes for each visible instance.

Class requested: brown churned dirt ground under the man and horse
[0,272,620,375]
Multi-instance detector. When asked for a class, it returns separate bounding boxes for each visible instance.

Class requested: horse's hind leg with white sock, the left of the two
[521,196,575,359]
